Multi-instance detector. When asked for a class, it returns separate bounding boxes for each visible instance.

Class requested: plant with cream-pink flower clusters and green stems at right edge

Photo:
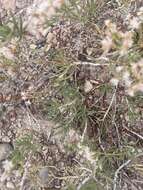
[102,7,143,96]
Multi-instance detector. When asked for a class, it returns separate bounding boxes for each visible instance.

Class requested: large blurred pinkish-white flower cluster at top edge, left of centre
[24,0,64,38]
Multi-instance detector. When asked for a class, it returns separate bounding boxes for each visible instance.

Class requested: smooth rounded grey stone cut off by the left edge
[0,143,13,161]
